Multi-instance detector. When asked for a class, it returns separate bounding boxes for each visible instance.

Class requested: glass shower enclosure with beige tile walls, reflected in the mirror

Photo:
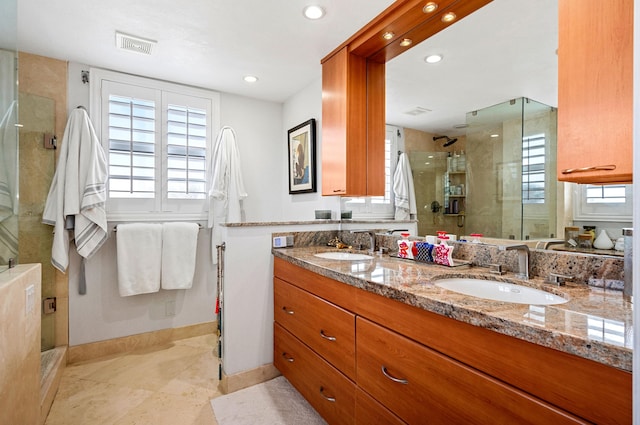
[405,98,564,240]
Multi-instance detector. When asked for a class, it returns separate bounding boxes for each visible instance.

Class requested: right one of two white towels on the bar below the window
[161,223,199,289]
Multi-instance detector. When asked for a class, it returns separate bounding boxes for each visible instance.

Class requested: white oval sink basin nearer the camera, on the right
[436,278,567,305]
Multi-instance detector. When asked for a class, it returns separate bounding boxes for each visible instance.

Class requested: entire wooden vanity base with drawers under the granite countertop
[274,258,632,424]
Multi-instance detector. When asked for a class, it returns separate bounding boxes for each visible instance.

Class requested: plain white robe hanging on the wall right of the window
[208,127,247,264]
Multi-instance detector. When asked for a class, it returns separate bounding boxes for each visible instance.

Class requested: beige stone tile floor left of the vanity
[45,335,220,425]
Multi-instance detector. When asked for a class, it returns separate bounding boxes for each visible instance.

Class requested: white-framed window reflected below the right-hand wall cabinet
[573,184,633,221]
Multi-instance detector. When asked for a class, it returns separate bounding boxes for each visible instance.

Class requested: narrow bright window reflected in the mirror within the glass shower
[522,134,545,204]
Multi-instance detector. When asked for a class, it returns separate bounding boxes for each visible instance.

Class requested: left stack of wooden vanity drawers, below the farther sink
[273,259,356,424]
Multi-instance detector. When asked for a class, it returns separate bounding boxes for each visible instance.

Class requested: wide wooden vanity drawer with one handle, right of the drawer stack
[357,317,585,424]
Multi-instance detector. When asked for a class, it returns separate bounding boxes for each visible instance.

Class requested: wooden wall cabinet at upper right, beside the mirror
[558,0,633,183]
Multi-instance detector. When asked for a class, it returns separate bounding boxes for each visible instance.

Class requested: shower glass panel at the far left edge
[0,0,18,272]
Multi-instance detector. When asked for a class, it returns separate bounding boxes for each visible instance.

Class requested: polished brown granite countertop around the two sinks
[272,246,633,372]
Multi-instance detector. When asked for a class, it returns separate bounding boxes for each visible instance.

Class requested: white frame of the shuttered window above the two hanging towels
[89,68,220,221]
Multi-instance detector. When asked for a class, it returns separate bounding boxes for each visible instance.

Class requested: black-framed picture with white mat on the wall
[288,118,316,194]
